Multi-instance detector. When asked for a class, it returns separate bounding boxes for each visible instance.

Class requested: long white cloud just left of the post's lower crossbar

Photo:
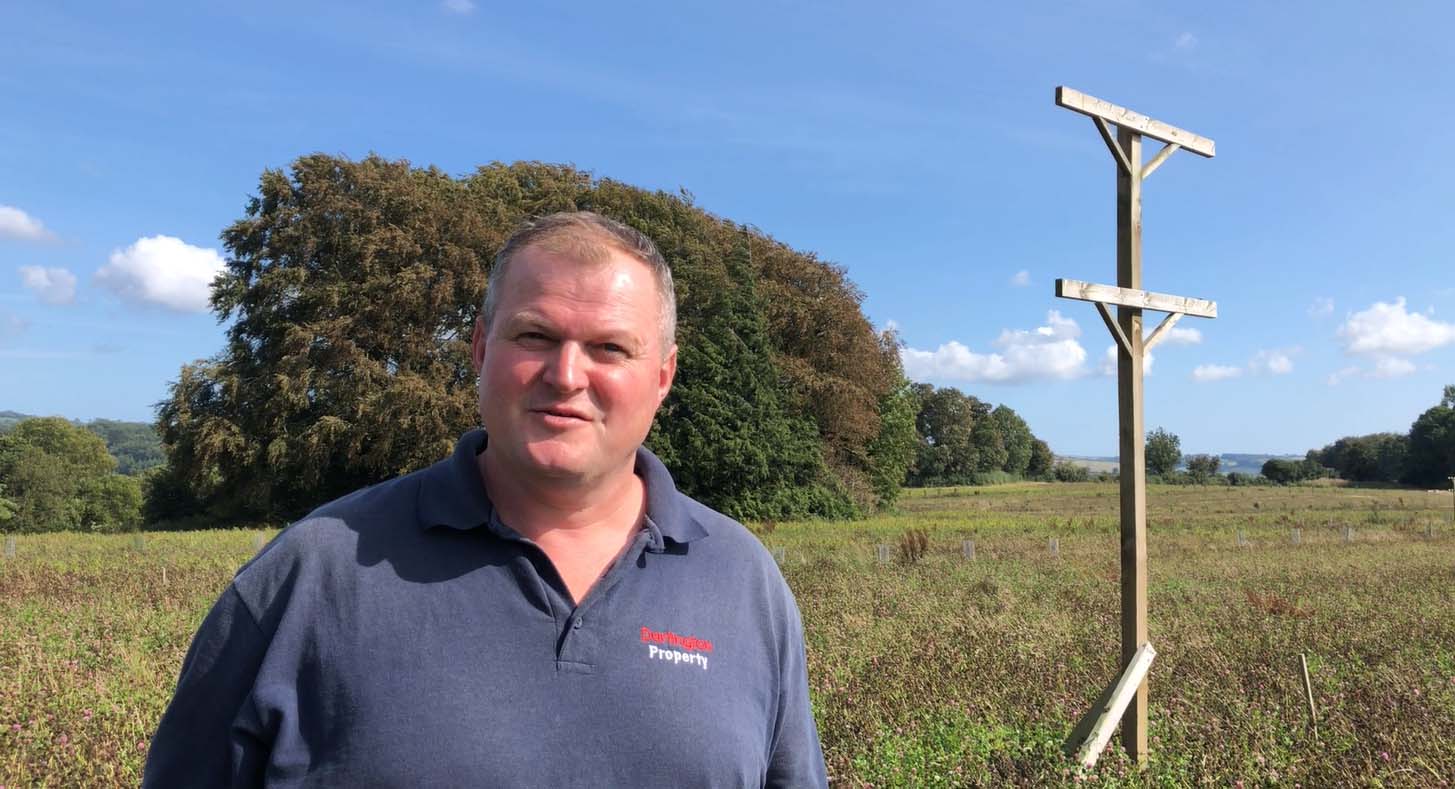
[899,310,1087,383]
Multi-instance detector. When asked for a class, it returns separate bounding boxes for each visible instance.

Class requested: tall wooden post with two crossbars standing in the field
[1056,86,1222,764]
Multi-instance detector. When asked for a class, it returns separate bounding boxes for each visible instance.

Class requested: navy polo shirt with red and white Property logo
[144,431,826,788]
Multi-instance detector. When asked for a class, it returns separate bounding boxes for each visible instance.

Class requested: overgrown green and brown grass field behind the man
[0,483,1455,788]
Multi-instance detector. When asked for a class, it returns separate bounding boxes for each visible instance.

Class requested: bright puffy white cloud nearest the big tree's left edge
[96,236,224,312]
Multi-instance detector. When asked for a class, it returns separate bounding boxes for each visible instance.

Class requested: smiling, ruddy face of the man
[471,247,677,482]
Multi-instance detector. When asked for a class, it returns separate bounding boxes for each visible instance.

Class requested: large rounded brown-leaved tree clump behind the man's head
[153,154,902,520]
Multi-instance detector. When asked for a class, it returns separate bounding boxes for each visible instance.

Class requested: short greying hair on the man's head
[480,211,677,354]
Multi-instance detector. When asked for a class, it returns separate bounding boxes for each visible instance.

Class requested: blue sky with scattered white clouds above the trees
[0,0,1455,454]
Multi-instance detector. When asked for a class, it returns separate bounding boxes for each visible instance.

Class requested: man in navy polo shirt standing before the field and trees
[144,213,826,786]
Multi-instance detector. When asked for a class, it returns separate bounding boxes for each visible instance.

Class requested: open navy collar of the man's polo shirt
[416,428,707,553]
